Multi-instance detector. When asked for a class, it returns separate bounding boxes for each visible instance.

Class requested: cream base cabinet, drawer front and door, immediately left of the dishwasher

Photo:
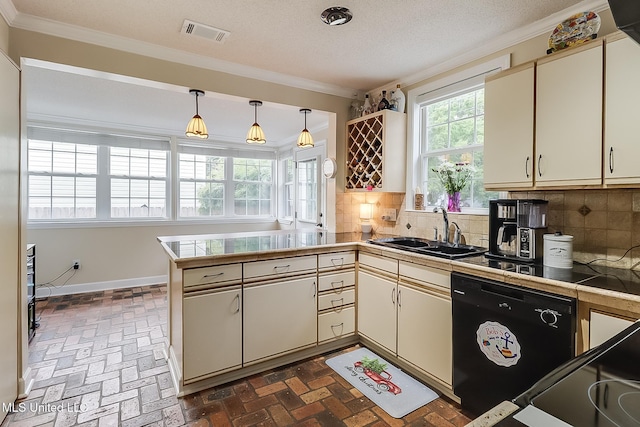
[397,261,453,387]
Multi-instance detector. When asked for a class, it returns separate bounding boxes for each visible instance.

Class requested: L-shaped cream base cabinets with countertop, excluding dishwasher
[158,230,640,400]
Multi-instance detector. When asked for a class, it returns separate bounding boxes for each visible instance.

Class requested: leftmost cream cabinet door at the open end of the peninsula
[183,286,242,381]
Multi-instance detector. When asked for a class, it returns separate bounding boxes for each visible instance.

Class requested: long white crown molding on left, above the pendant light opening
[0,0,358,98]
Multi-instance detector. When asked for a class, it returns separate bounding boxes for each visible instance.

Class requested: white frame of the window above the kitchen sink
[405,55,511,215]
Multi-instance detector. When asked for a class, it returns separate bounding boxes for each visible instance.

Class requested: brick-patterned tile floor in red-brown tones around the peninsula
[2,285,470,427]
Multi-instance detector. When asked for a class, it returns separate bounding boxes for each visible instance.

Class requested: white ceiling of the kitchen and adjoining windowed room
[0,0,607,143]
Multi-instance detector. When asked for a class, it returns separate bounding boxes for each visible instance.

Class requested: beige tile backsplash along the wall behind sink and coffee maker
[336,189,640,269]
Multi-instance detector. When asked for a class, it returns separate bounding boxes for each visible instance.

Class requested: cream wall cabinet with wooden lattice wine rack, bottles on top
[346,110,407,192]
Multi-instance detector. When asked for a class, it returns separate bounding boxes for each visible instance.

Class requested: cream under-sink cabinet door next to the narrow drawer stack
[358,271,397,353]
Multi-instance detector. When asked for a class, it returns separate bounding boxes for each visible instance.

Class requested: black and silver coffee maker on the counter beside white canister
[486,199,549,262]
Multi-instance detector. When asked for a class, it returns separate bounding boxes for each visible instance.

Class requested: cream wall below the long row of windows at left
[27,221,278,297]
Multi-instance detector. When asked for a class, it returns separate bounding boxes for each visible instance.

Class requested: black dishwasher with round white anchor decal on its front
[451,273,576,416]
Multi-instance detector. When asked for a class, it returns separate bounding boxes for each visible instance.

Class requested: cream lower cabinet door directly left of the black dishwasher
[398,284,453,384]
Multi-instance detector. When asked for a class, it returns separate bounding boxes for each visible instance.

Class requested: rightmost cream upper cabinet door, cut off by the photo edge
[604,36,640,184]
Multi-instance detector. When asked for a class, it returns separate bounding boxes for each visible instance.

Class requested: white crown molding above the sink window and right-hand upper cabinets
[369,0,609,93]
